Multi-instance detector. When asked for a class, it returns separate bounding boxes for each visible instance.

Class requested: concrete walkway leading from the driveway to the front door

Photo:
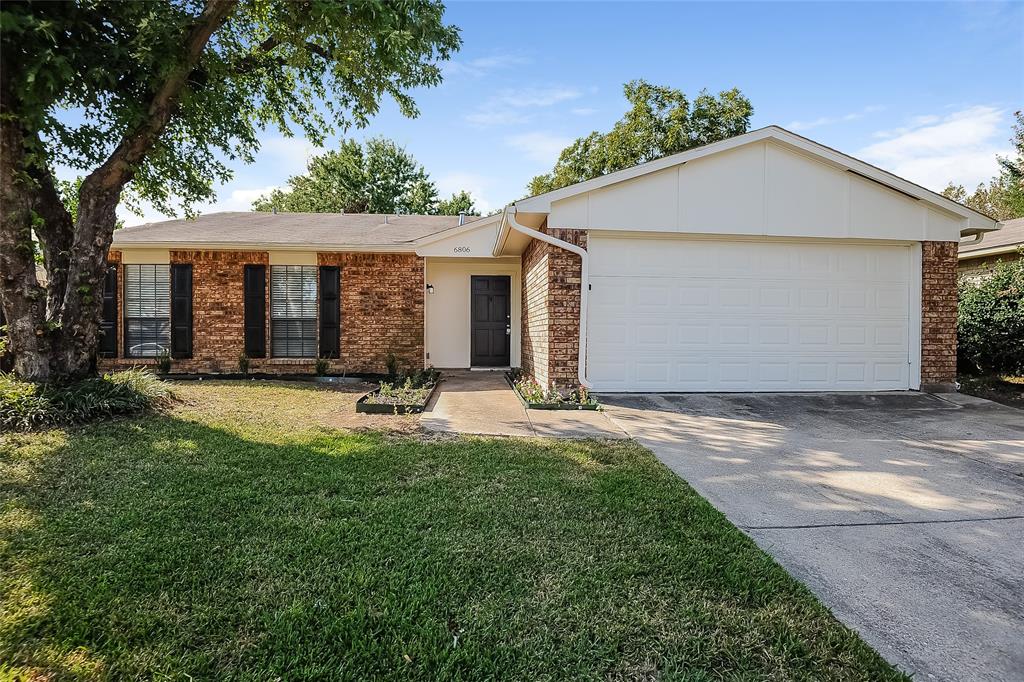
[420,370,628,438]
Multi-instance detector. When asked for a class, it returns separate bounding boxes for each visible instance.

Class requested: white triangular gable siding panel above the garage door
[548,140,968,241]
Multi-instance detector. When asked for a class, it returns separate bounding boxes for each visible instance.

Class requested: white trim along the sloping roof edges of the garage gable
[515,126,998,231]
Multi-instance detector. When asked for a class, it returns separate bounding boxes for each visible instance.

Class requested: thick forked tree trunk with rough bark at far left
[0,0,237,382]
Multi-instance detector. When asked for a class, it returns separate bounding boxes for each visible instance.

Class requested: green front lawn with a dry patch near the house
[0,382,900,680]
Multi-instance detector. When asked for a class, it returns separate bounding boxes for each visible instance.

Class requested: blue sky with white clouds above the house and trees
[114,2,1024,224]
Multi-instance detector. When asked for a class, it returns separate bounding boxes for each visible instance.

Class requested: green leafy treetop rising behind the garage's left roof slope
[527,80,754,195]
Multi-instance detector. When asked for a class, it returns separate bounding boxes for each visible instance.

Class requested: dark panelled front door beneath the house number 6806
[469,274,512,367]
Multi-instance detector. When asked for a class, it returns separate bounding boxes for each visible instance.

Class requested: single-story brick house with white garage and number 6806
[100,127,998,391]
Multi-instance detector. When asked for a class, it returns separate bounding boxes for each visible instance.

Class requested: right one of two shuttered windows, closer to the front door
[270,265,316,357]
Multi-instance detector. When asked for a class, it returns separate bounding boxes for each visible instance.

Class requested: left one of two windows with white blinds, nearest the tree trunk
[124,265,171,357]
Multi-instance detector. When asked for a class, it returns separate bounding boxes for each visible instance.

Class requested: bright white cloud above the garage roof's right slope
[856,105,1010,191]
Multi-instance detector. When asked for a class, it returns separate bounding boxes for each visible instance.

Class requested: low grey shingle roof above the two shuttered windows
[113,211,480,250]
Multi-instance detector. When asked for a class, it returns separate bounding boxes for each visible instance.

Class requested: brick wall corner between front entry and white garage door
[522,228,587,387]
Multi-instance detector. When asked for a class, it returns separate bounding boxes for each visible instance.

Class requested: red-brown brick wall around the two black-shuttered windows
[99,251,424,374]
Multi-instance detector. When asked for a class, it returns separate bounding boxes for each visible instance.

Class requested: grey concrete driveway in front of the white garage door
[601,393,1024,681]
